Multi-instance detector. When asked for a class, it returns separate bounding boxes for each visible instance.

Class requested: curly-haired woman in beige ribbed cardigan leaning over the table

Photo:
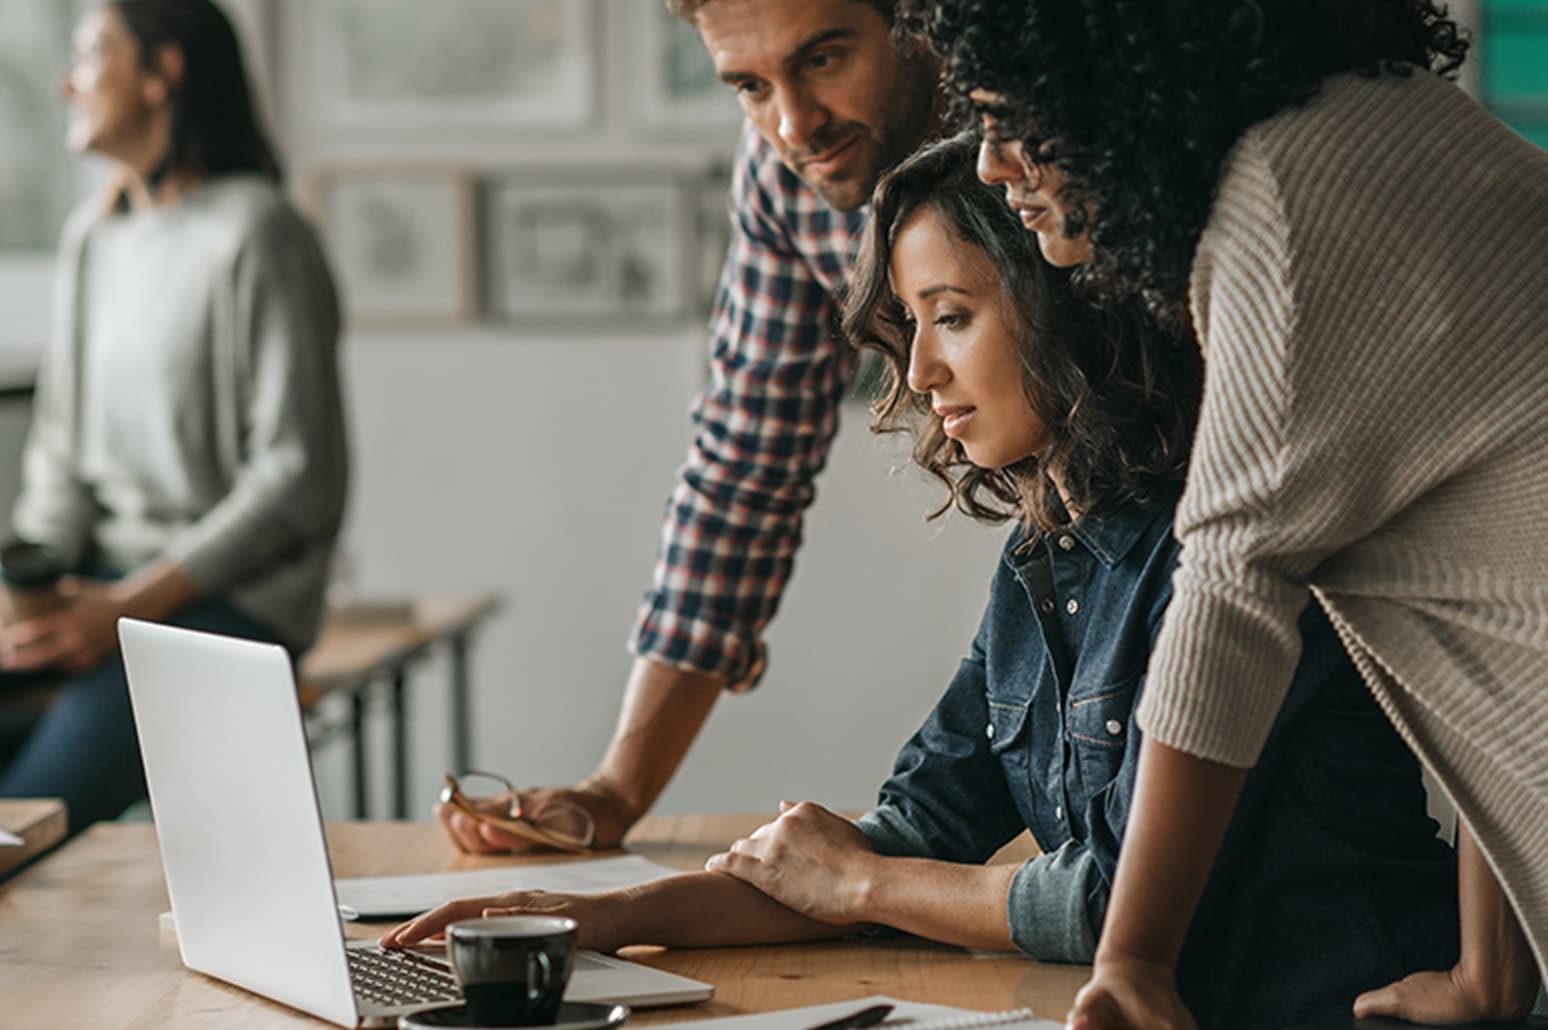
[907,0,1548,1027]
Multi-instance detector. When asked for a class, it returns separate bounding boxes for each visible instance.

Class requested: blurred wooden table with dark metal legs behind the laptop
[300,592,500,819]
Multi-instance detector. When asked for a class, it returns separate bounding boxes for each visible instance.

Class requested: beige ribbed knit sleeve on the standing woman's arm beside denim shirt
[1139,128,1307,767]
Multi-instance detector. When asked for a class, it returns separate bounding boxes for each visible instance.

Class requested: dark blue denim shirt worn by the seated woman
[859,488,1457,1030]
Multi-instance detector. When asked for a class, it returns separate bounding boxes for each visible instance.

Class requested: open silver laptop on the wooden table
[119,620,714,1027]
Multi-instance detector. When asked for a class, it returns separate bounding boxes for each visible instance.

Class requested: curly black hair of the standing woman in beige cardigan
[899,0,1469,318]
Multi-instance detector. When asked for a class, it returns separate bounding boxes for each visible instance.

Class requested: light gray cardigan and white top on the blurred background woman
[12,175,348,647]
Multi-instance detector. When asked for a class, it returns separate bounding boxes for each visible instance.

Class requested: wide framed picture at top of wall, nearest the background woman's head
[297,0,596,136]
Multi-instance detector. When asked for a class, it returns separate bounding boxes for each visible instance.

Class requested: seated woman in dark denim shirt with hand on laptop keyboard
[384,138,1457,1030]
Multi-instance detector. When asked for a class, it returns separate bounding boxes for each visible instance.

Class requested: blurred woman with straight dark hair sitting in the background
[0,0,347,832]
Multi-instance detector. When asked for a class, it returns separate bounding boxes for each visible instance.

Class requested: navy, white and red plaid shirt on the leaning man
[630,125,867,691]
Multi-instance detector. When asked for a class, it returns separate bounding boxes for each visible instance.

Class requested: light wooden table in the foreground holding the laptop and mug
[0,816,1087,1030]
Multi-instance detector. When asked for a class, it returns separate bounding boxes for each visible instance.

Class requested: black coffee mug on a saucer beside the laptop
[446,915,576,1027]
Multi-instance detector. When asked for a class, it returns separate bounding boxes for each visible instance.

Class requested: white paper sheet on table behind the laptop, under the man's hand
[334,855,681,918]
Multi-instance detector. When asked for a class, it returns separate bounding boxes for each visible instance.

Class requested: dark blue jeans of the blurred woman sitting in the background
[0,601,277,835]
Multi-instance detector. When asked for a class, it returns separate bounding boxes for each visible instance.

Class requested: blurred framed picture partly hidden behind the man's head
[628,3,741,138]
